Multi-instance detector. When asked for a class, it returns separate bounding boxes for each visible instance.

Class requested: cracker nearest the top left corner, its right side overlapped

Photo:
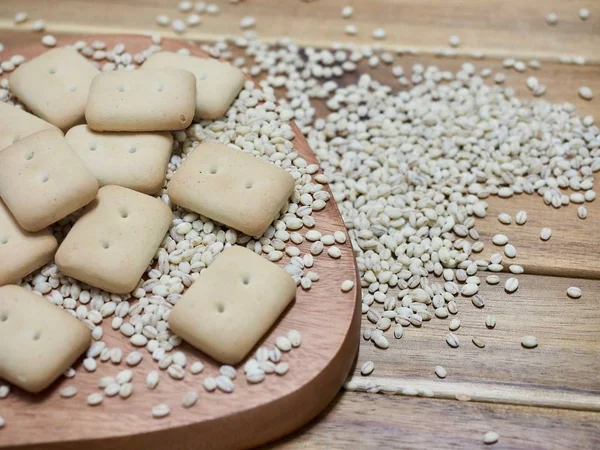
[10,47,99,131]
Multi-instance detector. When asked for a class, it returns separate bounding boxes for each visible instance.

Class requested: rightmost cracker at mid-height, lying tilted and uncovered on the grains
[168,142,295,236]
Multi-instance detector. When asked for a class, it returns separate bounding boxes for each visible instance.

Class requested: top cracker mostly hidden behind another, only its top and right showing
[141,52,246,119]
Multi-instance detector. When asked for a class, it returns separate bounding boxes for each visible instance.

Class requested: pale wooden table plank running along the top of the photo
[0,0,600,61]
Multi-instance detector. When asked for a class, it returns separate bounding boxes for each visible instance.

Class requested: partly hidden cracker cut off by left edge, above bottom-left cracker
[0,200,58,286]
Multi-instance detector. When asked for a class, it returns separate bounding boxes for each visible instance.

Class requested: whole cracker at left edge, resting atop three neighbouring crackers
[0,130,98,232]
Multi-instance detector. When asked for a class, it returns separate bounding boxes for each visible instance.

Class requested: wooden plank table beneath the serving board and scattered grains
[0,0,600,449]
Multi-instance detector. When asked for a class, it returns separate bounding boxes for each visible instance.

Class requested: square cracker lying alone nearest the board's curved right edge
[169,246,296,364]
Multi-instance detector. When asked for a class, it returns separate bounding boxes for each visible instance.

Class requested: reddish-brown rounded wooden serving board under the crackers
[0,35,361,450]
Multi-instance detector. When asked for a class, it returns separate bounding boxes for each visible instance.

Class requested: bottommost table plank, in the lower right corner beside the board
[268,392,600,450]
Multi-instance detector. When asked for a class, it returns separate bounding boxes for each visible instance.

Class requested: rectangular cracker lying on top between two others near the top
[85,69,196,131]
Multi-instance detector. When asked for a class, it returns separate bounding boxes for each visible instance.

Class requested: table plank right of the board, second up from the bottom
[355,274,600,411]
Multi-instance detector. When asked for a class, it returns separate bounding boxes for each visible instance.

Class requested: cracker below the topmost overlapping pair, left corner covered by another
[65,125,173,194]
